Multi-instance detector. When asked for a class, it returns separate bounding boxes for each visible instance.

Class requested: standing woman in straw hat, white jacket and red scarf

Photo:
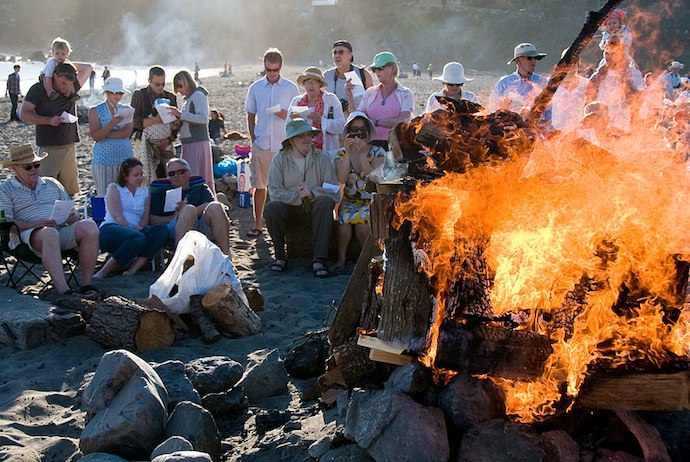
[288,67,345,158]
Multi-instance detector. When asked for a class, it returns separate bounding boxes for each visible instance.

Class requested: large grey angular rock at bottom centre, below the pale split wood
[345,390,450,462]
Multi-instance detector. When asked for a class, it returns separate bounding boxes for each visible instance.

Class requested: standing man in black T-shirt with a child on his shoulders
[19,62,92,195]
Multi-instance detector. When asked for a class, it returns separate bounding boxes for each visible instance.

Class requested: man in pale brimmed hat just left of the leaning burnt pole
[489,43,549,118]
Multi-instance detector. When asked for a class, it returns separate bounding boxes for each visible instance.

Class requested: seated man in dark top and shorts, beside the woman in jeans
[150,157,230,255]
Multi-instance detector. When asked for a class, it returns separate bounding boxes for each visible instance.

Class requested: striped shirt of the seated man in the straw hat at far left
[0,177,71,221]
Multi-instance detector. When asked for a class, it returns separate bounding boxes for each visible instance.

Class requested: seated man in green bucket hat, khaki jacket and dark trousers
[264,119,339,278]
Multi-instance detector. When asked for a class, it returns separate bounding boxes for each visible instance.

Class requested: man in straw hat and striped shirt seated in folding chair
[0,144,98,294]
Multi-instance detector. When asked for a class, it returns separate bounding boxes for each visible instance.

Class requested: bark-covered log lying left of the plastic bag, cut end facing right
[86,296,175,351]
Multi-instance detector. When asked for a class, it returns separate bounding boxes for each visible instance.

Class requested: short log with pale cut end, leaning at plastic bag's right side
[201,284,261,337]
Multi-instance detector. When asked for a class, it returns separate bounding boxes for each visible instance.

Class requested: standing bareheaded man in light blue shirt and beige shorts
[244,48,299,237]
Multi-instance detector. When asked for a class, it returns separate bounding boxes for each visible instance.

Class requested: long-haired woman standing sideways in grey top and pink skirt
[169,71,216,196]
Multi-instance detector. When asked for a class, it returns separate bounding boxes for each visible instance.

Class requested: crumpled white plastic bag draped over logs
[149,230,249,314]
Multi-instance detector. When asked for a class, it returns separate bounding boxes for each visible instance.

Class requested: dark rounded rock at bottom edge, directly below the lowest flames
[457,419,545,462]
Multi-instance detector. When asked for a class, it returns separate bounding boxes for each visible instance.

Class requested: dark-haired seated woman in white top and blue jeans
[94,157,168,278]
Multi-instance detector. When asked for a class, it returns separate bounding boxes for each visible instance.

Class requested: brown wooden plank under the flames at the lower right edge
[577,371,690,411]
